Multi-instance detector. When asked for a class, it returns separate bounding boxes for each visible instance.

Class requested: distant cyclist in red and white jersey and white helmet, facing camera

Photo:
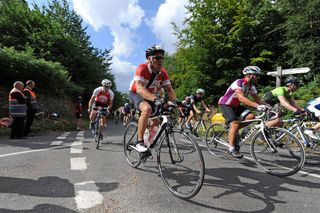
[88,79,114,129]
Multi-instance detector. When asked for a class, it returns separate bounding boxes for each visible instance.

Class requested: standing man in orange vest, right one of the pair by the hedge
[23,80,39,136]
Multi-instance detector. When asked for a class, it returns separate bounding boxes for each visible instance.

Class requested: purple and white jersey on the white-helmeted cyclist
[218,78,257,108]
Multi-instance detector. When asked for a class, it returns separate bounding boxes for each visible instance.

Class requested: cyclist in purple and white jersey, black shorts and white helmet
[218,66,267,158]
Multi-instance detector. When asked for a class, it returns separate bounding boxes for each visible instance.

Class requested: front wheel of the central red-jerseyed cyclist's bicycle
[157,130,205,199]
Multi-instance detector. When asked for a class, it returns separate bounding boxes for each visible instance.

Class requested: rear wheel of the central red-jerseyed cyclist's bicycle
[123,122,141,168]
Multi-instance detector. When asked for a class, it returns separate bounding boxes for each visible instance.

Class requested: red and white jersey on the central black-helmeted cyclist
[129,63,171,93]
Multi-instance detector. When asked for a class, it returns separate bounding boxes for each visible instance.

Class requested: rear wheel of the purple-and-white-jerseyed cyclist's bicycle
[205,123,228,156]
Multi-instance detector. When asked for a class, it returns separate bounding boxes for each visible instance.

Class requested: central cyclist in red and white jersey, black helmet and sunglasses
[129,45,180,152]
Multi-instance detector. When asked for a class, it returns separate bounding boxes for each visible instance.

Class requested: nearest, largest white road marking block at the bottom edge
[74,181,103,210]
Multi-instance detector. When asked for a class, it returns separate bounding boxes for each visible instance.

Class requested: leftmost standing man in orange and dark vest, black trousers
[9,81,27,139]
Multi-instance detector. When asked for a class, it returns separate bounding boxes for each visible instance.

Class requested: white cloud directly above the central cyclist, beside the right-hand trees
[146,0,188,53]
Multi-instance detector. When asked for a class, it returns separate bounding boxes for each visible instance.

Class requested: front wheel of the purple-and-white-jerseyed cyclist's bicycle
[250,127,305,177]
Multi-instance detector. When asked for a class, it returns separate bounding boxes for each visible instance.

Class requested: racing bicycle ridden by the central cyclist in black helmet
[123,104,205,199]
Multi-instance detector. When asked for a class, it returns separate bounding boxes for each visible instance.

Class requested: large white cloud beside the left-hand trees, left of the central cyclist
[72,0,145,56]
